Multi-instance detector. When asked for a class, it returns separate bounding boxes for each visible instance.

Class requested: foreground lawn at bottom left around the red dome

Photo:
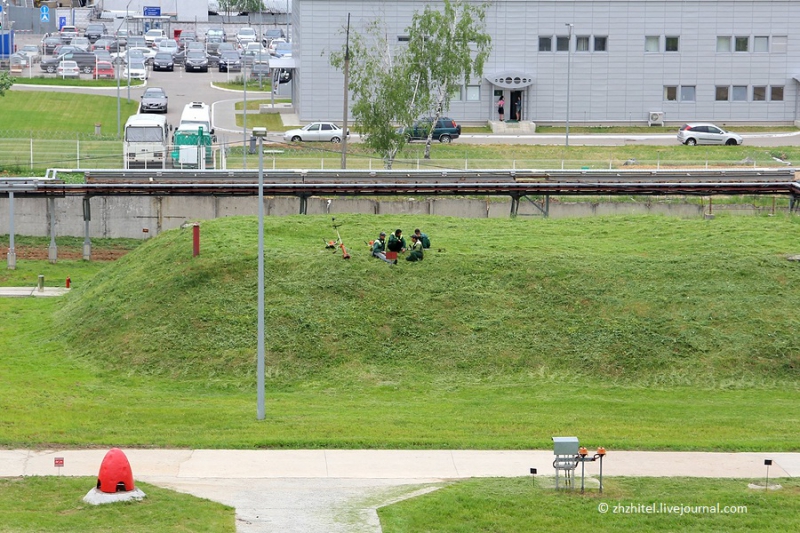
[0,476,236,533]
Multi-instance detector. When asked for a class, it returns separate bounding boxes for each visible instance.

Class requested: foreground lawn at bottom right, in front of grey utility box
[378,478,800,533]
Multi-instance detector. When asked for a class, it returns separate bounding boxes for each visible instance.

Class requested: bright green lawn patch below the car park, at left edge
[0,90,139,135]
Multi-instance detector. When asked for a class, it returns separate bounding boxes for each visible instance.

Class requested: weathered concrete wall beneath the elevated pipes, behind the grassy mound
[0,196,759,239]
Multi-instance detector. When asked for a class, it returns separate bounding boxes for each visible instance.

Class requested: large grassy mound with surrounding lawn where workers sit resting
[0,215,800,451]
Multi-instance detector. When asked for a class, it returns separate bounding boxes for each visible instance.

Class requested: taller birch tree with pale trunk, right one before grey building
[408,0,492,159]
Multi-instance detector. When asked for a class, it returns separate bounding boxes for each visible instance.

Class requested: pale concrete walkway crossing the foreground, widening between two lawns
[0,449,800,533]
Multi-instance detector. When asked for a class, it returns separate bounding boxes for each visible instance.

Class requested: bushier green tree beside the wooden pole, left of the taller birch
[330,21,424,168]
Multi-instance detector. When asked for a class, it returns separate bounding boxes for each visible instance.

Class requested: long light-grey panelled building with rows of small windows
[292,0,800,125]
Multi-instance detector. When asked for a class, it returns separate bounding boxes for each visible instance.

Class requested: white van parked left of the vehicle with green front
[123,114,169,170]
